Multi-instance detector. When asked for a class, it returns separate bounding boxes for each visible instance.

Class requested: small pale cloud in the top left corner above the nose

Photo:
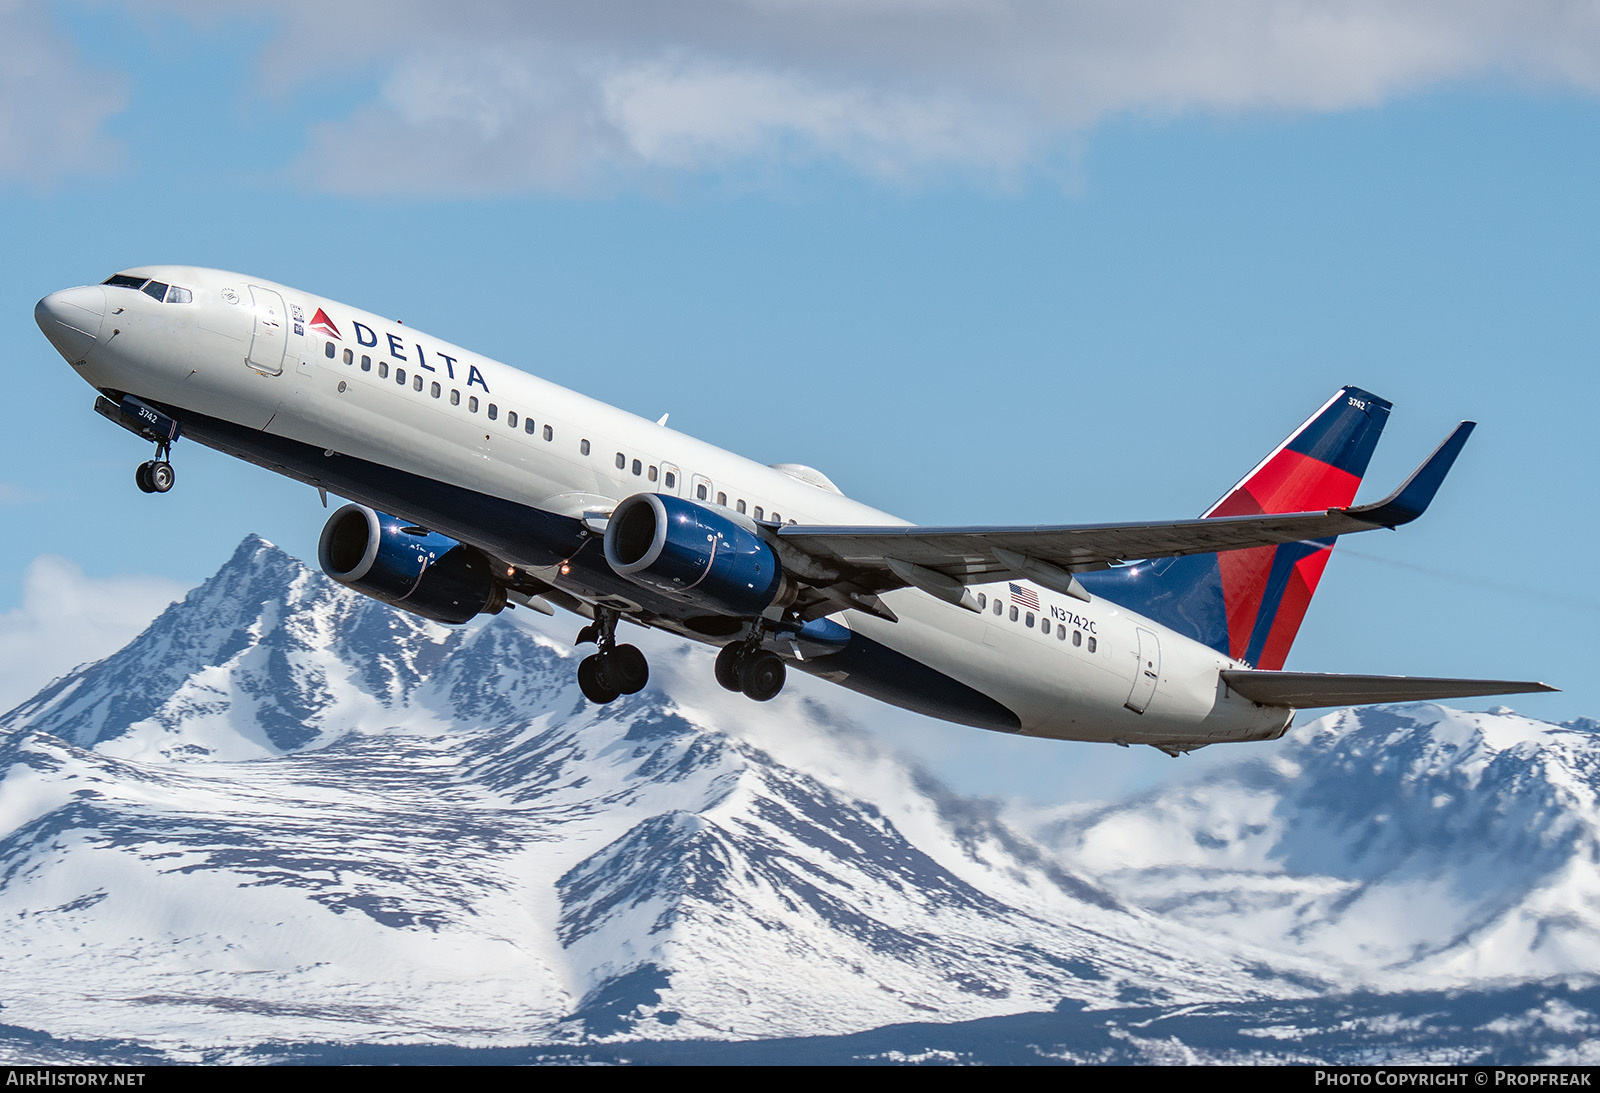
[0,0,125,186]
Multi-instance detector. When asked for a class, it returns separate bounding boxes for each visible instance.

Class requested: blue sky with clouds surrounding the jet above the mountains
[0,0,1600,799]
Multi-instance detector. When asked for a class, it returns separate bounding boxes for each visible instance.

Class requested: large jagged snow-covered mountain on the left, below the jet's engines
[0,539,1310,1043]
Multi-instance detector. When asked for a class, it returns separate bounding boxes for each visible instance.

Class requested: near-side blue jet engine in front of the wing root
[605,493,792,618]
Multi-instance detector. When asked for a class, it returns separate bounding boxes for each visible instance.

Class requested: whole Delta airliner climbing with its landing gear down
[35,266,1550,755]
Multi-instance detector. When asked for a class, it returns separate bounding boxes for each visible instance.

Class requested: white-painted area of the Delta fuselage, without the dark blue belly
[42,266,1290,747]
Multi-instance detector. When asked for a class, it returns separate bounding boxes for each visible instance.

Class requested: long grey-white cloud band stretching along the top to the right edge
[156,0,1600,194]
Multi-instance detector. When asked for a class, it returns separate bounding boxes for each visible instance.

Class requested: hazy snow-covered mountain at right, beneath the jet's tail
[1034,706,1600,987]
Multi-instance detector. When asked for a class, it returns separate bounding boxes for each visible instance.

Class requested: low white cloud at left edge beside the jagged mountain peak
[0,554,186,712]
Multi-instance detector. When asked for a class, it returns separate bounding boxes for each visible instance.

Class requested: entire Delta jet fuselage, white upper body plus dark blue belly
[38,266,1290,751]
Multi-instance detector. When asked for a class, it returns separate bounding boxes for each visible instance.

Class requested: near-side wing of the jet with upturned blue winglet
[778,421,1474,610]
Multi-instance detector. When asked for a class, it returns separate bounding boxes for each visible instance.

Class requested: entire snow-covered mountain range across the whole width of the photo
[0,538,1600,1058]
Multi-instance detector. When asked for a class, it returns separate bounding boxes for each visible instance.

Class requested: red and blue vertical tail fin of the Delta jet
[1080,387,1390,669]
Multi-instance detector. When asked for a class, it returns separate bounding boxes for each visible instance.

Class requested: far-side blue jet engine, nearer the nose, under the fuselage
[317,504,506,623]
